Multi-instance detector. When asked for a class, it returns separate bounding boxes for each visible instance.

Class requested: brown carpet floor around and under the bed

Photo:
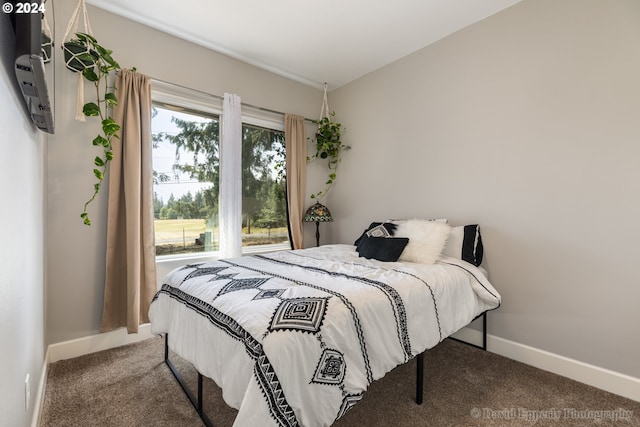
[41,338,640,427]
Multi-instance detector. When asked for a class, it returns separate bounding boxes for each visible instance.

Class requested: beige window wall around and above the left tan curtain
[47,0,322,343]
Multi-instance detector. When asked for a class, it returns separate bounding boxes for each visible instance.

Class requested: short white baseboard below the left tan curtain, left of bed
[48,323,153,363]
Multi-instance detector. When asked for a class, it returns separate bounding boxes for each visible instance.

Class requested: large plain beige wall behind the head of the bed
[325,0,640,378]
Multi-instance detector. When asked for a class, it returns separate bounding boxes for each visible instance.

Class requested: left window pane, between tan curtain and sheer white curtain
[151,103,220,256]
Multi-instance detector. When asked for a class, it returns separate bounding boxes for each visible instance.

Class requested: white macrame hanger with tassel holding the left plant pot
[62,0,93,122]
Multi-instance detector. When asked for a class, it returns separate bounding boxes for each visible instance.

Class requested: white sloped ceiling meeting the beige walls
[86,0,520,90]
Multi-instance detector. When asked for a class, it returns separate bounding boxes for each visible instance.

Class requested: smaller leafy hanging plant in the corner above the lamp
[307,111,351,200]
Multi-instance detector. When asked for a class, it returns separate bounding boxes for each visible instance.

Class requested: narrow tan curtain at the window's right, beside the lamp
[284,114,307,249]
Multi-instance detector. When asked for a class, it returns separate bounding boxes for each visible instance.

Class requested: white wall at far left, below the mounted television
[0,13,47,426]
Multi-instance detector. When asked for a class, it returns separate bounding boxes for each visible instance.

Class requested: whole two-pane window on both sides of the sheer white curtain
[152,88,289,256]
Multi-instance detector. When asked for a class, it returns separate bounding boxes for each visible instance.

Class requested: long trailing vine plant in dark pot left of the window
[63,33,120,225]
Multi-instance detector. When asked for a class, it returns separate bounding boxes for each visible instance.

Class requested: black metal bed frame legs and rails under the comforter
[164,311,487,427]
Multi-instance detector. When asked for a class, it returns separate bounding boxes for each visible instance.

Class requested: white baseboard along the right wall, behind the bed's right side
[453,328,640,402]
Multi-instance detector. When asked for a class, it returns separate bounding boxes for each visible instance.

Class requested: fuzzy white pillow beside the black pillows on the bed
[394,219,451,264]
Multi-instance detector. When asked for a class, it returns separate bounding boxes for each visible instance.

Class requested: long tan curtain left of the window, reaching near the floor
[100,70,156,334]
